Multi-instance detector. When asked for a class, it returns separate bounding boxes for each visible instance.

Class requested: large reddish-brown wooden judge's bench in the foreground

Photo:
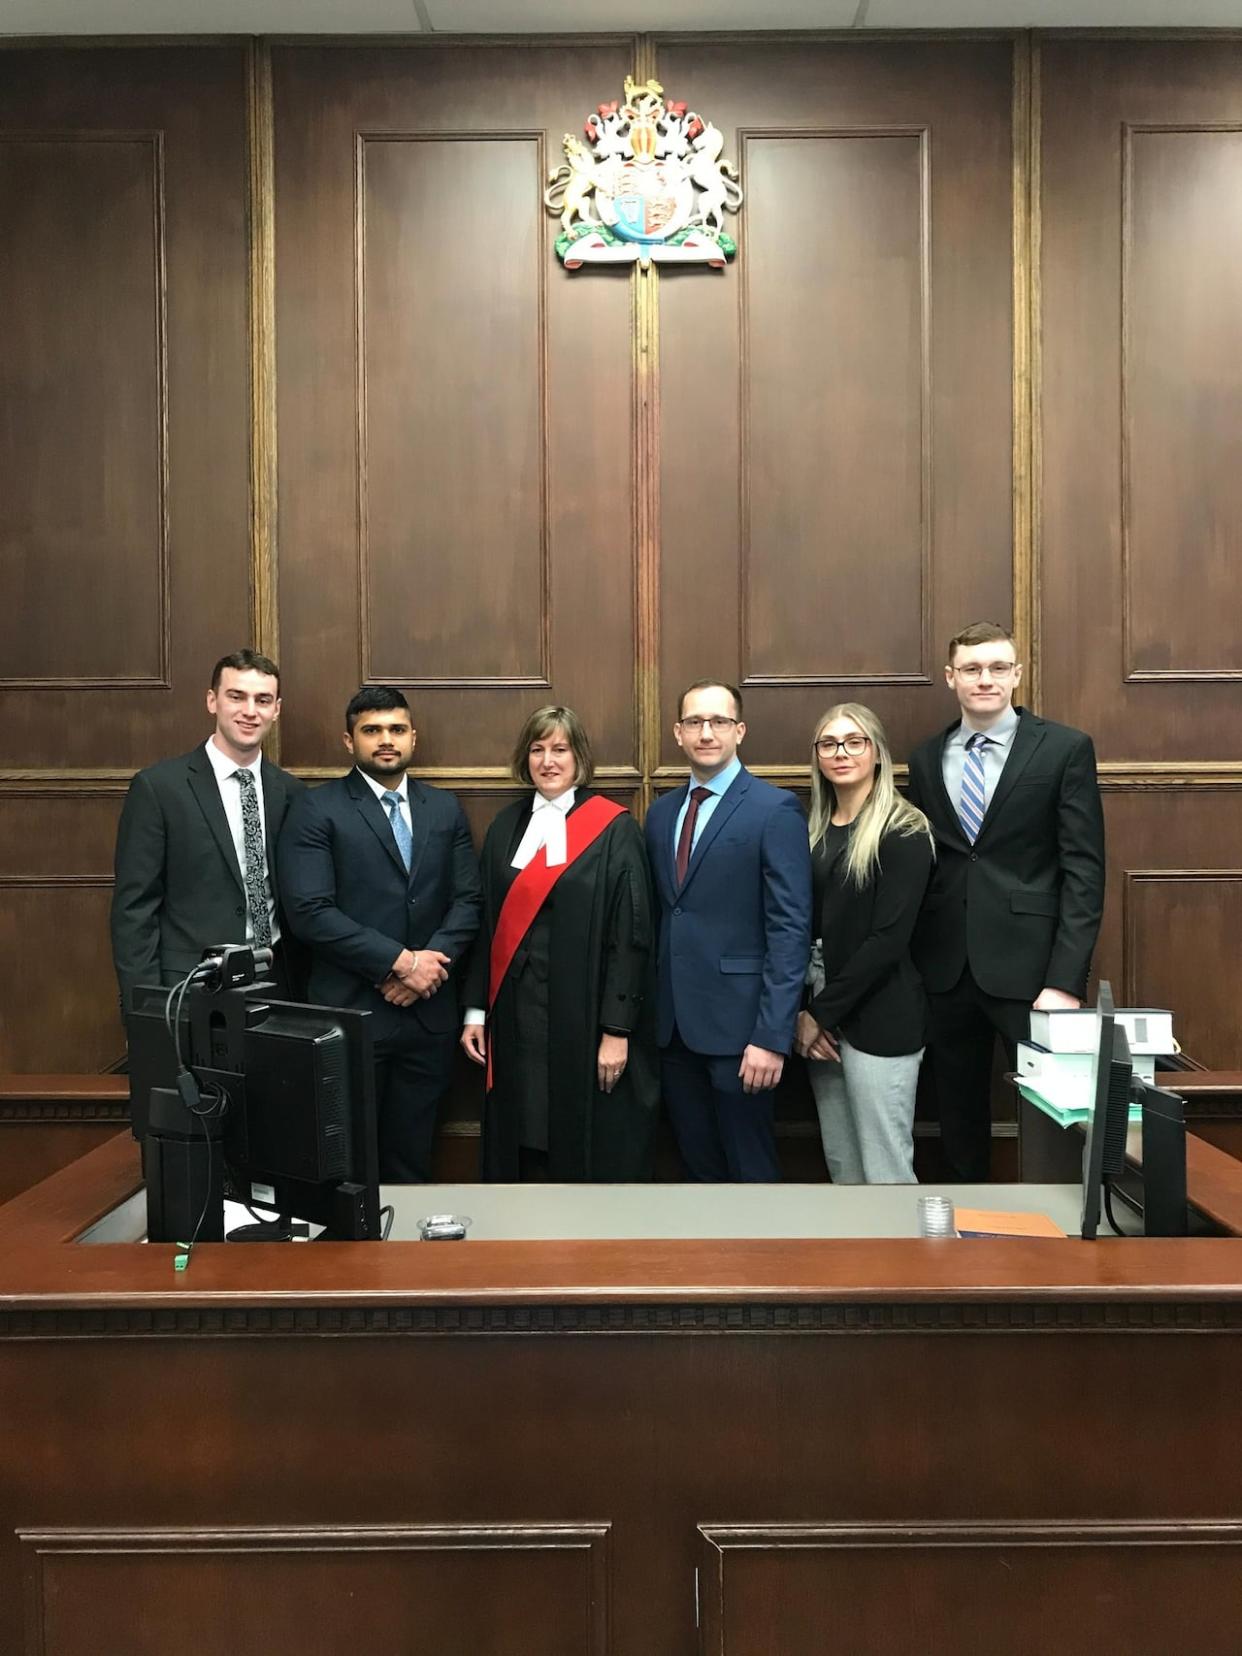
[0,1134,1242,1656]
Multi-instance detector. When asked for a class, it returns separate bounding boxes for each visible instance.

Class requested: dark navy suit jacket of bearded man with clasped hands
[280,770,482,1035]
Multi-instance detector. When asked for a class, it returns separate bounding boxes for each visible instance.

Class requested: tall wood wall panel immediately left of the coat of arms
[275,41,636,767]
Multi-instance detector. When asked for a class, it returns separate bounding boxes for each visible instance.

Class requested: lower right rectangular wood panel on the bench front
[702,1524,1242,1656]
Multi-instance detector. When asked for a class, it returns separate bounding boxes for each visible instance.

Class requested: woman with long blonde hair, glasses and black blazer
[797,702,936,1184]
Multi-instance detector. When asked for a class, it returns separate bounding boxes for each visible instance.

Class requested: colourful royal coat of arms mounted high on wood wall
[543,76,742,270]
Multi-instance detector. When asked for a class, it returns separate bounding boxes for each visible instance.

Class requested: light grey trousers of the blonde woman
[806,946,922,1184]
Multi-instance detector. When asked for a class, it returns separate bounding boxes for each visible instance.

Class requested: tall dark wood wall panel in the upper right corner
[1040,40,1242,751]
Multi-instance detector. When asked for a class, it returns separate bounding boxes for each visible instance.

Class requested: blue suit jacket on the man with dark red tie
[647,770,811,1055]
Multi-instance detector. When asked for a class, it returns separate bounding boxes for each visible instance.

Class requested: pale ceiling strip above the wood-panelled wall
[0,0,1242,35]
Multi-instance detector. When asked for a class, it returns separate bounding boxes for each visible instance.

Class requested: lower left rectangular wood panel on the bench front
[23,1525,608,1656]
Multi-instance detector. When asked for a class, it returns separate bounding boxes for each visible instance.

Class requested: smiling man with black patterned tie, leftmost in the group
[111,649,305,1010]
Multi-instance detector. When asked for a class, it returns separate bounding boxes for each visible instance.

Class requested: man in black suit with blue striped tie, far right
[909,621,1105,1182]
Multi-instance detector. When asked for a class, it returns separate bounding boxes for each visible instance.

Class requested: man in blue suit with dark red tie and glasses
[647,679,811,1181]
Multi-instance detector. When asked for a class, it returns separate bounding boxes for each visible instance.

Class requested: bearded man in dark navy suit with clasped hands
[280,686,482,1184]
